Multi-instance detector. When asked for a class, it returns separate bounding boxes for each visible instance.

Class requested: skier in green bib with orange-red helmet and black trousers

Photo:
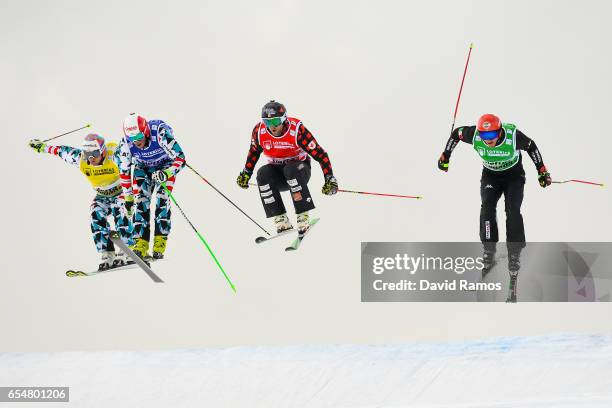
[438,113,552,273]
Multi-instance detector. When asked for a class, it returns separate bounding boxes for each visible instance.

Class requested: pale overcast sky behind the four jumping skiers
[0,0,612,351]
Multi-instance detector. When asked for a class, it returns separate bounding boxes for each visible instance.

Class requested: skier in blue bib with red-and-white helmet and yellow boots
[119,113,185,259]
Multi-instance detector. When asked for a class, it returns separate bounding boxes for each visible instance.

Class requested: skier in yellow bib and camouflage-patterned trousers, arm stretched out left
[28,133,134,271]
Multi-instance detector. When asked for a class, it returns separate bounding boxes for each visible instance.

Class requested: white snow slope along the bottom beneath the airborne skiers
[0,335,612,408]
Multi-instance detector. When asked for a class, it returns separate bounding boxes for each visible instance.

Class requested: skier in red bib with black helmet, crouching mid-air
[236,101,338,233]
